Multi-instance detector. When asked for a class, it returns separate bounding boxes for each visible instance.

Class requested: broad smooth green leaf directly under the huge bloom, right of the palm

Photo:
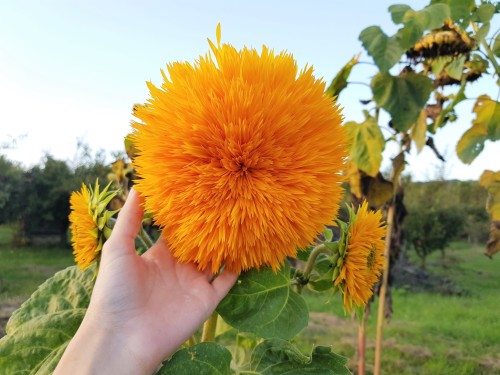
[217,264,309,339]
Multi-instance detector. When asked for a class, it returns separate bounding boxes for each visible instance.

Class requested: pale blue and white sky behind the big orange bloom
[0,0,500,181]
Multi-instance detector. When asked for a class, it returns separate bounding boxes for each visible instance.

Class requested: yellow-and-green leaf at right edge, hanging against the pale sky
[457,95,500,164]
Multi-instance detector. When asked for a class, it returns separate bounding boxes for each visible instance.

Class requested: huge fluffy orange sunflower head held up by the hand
[133,27,346,272]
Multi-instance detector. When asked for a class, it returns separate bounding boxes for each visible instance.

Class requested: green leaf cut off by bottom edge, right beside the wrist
[156,342,231,375]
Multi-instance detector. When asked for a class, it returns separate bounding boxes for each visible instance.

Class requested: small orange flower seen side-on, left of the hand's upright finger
[69,182,117,270]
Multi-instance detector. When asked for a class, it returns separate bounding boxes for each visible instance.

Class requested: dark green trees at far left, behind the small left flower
[0,144,111,245]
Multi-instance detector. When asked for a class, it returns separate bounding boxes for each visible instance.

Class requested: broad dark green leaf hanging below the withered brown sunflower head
[371,73,434,132]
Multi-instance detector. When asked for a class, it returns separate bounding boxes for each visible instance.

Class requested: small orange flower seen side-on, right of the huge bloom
[334,201,386,311]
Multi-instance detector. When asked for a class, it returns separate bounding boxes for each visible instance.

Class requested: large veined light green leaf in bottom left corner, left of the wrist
[0,266,94,374]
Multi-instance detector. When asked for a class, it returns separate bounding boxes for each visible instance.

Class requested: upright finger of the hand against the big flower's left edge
[107,189,144,250]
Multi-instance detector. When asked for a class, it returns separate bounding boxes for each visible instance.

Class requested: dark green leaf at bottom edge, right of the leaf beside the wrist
[250,339,351,375]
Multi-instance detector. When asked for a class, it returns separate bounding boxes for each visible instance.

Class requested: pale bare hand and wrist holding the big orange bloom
[54,190,238,375]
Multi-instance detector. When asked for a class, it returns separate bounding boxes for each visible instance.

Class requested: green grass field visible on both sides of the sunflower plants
[0,226,500,375]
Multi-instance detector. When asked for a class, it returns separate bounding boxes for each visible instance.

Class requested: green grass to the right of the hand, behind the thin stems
[302,243,500,375]
